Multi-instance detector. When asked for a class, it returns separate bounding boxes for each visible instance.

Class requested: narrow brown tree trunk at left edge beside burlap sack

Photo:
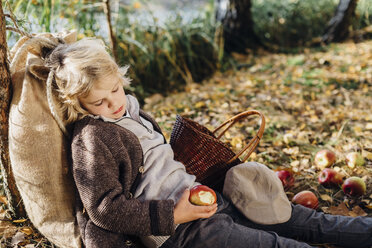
[0,1,25,217]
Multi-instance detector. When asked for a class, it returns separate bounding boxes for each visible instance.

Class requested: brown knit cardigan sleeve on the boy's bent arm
[71,120,174,236]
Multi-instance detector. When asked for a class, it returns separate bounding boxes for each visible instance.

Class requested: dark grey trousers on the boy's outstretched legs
[162,194,372,248]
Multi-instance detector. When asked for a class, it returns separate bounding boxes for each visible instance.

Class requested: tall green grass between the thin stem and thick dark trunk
[116,5,219,97]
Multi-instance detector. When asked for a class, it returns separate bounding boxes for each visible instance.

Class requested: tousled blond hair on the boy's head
[46,38,130,124]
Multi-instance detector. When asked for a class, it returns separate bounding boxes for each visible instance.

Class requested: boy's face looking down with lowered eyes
[79,74,127,119]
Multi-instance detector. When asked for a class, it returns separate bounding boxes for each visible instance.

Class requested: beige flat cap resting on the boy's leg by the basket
[223,162,292,225]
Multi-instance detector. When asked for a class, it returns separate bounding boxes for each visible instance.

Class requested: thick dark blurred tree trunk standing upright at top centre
[217,0,262,53]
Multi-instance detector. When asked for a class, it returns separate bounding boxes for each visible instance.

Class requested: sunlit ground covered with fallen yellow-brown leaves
[0,41,372,248]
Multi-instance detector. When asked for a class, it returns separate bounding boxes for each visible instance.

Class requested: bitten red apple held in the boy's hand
[189,185,217,206]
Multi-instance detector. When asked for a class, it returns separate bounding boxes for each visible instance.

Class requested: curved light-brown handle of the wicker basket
[213,110,265,164]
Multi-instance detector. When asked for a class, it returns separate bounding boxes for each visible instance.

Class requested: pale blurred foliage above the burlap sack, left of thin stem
[2,0,106,38]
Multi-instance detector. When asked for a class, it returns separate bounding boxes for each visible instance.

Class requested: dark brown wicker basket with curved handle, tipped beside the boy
[170,110,265,190]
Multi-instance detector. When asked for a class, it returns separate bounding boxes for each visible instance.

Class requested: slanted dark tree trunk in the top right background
[322,0,358,44]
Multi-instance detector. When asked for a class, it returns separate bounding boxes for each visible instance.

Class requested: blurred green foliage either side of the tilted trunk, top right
[252,0,372,48]
